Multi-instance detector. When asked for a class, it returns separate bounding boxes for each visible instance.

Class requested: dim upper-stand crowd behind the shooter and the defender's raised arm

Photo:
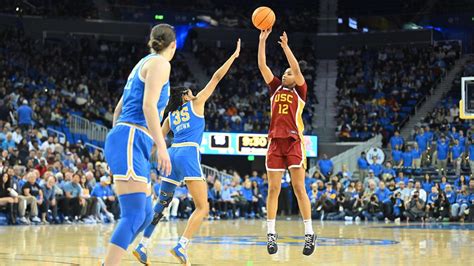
[192,37,317,134]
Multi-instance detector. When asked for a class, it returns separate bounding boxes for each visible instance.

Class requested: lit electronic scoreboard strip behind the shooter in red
[201,132,318,157]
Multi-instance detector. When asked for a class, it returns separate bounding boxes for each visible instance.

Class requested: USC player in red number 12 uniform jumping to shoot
[258,29,317,256]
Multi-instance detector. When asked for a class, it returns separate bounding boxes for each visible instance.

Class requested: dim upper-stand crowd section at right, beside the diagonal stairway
[335,42,460,142]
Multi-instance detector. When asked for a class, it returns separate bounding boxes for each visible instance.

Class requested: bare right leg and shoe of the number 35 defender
[170,180,209,265]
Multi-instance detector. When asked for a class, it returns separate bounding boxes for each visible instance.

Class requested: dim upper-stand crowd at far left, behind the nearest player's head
[0,30,195,130]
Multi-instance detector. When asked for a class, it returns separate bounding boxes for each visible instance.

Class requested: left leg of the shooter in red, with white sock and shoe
[267,171,284,254]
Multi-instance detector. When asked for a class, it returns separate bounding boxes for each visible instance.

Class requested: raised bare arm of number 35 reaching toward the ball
[193,39,240,112]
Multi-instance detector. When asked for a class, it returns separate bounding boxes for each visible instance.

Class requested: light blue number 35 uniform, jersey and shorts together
[163,102,205,185]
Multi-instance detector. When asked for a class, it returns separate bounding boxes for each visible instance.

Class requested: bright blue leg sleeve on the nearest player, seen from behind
[110,193,146,250]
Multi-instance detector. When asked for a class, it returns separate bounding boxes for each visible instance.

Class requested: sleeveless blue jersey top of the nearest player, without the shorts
[118,54,170,127]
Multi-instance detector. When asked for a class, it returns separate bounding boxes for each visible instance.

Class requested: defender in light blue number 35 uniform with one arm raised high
[134,39,240,265]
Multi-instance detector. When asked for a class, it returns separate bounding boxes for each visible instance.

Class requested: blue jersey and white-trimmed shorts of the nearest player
[104,54,170,183]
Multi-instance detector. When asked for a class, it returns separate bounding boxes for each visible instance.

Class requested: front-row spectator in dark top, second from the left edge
[20,172,41,223]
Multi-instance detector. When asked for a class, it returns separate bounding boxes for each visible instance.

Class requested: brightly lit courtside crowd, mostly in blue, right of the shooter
[312,153,474,222]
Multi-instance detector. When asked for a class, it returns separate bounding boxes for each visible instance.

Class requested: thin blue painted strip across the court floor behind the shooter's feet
[157,236,399,246]
